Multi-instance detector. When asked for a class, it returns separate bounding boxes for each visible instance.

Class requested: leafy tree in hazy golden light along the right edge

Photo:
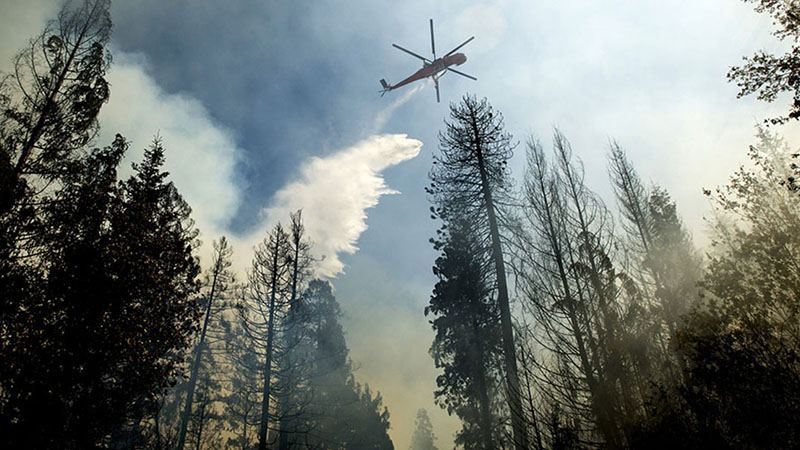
[639,131,800,449]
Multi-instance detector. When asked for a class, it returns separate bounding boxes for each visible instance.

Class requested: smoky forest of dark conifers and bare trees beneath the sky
[0,0,800,450]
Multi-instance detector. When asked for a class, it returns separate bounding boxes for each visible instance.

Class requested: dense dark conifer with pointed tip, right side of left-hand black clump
[106,138,201,446]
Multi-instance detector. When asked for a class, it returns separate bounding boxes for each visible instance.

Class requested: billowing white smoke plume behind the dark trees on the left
[97,51,244,248]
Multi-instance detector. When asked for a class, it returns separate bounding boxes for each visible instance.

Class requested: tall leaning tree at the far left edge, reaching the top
[0,0,115,440]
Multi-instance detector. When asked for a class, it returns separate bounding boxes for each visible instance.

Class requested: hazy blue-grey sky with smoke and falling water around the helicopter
[0,0,797,449]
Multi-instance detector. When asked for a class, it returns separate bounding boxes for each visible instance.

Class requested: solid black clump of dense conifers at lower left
[0,136,199,448]
